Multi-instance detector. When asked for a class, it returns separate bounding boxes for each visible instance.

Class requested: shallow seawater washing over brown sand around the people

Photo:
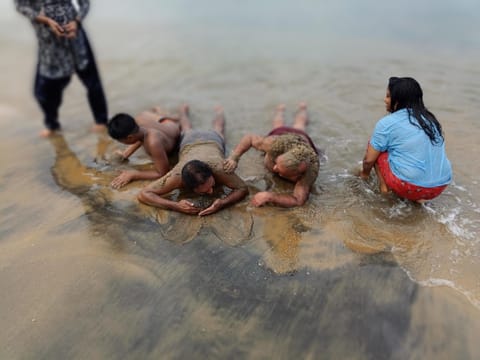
[0,0,480,359]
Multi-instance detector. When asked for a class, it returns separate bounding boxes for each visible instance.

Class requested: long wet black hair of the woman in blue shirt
[388,77,443,145]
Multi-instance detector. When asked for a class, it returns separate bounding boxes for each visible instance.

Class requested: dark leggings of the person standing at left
[34,28,108,130]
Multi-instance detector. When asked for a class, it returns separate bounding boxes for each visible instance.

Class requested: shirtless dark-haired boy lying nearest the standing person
[108,107,181,189]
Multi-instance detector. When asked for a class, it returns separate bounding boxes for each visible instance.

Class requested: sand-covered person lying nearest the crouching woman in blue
[224,102,320,207]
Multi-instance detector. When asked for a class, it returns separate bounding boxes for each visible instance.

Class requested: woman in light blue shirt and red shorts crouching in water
[360,77,452,201]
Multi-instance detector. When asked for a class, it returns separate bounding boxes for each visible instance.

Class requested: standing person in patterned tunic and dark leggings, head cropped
[15,0,108,137]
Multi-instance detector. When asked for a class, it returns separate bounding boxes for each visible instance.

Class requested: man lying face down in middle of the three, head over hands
[138,106,248,216]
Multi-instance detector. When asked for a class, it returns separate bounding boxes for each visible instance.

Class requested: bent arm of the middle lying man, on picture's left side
[138,172,200,215]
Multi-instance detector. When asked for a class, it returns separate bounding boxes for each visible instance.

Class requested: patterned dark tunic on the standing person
[15,0,90,79]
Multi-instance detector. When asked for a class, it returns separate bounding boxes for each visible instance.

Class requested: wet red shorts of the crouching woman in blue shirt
[377,152,447,201]
